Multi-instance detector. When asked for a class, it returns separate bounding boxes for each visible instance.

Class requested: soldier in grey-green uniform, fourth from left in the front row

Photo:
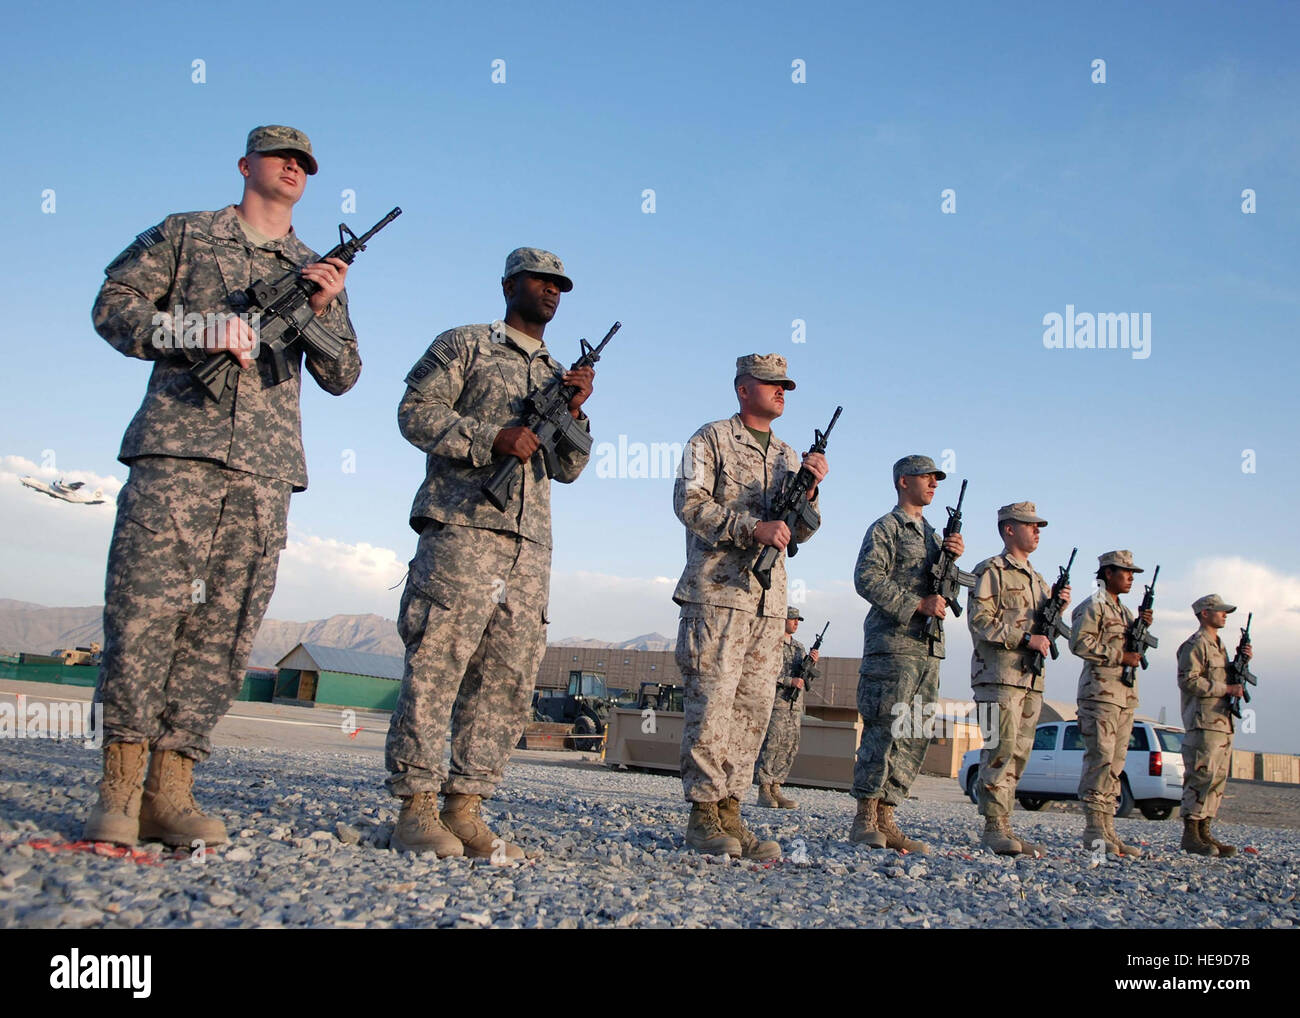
[849,455,966,853]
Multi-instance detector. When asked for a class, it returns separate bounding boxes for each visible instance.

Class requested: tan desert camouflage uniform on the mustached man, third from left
[672,413,820,802]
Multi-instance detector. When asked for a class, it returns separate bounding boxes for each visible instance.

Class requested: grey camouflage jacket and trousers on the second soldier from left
[385,322,590,797]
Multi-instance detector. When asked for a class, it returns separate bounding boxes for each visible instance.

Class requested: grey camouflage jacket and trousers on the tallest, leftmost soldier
[94,205,361,759]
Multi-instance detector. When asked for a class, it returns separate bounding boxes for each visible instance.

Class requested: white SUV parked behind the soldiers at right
[957,720,1183,820]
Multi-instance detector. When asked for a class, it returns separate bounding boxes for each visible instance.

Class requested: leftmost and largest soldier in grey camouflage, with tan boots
[83,125,361,848]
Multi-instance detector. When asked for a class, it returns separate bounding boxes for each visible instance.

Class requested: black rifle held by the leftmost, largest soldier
[190,208,402,403]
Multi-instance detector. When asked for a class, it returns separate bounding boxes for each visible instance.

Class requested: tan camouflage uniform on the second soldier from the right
[1070,589,1138,816]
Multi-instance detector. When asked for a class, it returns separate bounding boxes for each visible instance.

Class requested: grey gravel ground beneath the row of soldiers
[0,740,1300,930]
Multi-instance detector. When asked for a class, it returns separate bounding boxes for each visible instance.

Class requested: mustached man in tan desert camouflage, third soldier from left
[672,354,827,861]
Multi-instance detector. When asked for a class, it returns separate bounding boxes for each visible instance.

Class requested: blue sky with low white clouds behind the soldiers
[0,3,1300,748]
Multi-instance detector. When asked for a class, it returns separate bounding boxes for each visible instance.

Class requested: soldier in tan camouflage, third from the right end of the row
[966,502,1070,858]
